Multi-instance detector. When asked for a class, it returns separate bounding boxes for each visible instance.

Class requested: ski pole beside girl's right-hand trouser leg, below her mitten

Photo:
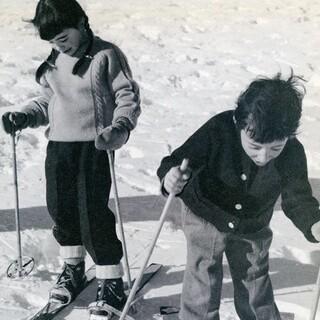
[107,150,132,289]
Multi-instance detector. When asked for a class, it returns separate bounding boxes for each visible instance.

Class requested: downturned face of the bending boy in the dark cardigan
[240,130,288,167]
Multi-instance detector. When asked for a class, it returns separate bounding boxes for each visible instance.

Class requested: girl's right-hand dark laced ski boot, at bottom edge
[89,278,127,320]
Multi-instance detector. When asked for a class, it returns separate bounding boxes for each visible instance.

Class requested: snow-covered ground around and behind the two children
[0,0,320,320]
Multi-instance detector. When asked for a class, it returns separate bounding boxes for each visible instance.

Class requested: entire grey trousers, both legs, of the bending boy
[180,206,281,320]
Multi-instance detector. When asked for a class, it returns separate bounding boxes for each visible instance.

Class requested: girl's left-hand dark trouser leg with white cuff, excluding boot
[45,141,84,258]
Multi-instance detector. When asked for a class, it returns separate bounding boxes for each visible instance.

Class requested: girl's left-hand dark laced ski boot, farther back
[50,261,86,305]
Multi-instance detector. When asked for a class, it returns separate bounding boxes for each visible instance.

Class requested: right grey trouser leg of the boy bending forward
[226,227,281,320]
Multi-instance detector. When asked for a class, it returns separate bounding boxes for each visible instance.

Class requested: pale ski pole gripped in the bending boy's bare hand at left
[119,159,188,320]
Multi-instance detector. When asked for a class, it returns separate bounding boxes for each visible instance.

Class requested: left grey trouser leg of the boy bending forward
[180,206,226,320]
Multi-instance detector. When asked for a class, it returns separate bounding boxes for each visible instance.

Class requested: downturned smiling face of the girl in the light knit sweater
[49,28,87,57]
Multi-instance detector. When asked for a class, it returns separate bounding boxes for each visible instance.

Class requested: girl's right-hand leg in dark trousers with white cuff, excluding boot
[77,142,122,279]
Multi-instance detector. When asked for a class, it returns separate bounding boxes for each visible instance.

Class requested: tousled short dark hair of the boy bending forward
[234,71,306,143]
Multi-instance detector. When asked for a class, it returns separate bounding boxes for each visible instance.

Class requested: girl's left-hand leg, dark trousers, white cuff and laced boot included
[46,141,85,304]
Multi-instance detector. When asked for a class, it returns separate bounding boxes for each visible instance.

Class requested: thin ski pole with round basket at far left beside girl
[7,126,34,278]
